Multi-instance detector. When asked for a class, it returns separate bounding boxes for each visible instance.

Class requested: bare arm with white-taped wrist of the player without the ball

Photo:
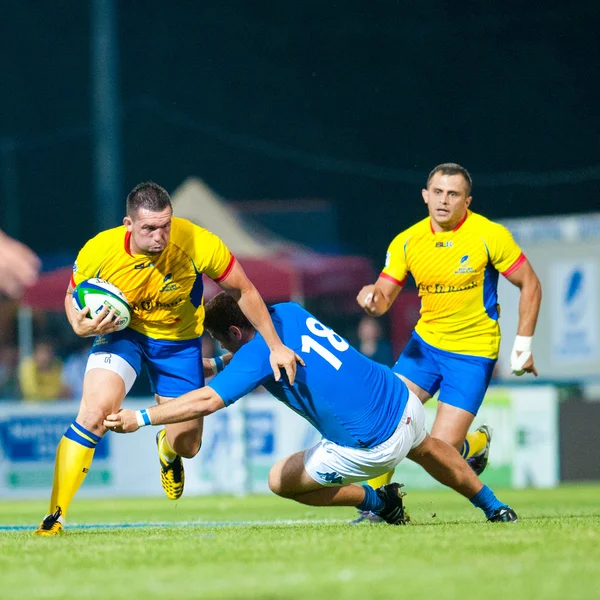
[507,260,542,377]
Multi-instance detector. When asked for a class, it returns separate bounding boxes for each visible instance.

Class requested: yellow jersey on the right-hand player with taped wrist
[381,211,525,359]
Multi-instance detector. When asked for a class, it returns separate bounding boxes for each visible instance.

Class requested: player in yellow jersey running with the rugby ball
[35,182,304,535]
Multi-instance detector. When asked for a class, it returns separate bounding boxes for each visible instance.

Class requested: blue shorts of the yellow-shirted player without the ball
[392,331,496,415]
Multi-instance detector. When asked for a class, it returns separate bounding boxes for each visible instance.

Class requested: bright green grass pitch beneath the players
[0,486,600,600]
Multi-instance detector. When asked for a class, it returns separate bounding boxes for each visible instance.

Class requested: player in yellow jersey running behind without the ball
[357,163,542,516]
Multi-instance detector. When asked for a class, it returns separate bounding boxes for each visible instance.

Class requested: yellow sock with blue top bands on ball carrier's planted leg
[48,421,101,519]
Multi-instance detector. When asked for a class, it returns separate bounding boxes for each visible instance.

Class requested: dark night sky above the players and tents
[0,0,600,261]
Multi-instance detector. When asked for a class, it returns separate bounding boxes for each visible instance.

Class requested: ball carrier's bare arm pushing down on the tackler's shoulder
[214,261,304,385]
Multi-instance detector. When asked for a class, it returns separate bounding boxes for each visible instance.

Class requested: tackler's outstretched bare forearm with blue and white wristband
[104,386,225,433]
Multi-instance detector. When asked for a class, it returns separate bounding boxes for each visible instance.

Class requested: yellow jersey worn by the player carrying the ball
[71,217,235,340]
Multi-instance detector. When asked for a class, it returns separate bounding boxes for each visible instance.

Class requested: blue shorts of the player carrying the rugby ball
[91,328,204,398]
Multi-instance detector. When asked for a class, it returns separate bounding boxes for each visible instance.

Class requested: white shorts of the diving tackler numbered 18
[304,391,427,487]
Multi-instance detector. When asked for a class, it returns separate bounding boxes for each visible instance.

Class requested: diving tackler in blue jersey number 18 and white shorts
[104,294,517,525]
